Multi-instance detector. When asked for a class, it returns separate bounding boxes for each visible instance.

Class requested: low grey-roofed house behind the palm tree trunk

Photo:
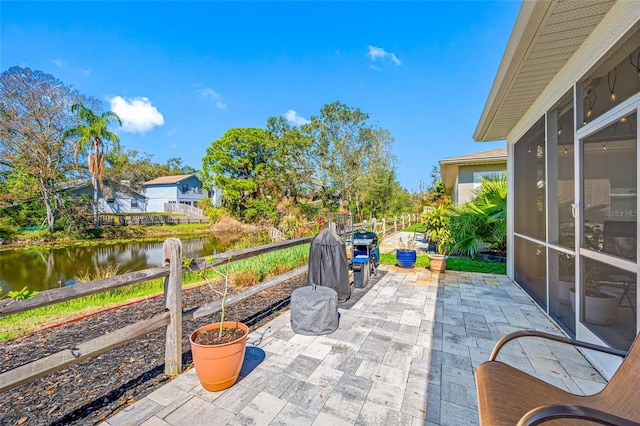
[66,180,147,214]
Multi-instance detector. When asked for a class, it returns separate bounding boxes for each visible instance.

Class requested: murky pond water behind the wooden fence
[0,235,235,293]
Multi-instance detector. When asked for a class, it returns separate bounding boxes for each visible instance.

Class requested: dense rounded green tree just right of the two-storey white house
[201,128,277,217]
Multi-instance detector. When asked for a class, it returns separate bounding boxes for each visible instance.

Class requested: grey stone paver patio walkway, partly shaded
[103,245,604,426]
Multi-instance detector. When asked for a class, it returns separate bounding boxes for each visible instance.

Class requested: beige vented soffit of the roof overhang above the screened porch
[473,0,616,141]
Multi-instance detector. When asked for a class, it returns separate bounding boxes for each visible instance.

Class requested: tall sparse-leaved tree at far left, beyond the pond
[0,66,95,231]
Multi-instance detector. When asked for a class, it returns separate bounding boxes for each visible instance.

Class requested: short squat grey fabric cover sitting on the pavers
[291,285,339,336]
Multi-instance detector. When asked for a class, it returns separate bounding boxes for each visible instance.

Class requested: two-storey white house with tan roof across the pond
[142,174,221,212]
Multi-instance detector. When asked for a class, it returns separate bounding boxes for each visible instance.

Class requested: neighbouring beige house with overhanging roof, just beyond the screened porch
[440,148,507,204]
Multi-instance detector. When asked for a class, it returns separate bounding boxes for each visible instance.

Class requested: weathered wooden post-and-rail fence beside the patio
[0,237,313,393]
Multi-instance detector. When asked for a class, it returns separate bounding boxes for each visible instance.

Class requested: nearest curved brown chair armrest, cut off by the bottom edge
[518,404,640,426]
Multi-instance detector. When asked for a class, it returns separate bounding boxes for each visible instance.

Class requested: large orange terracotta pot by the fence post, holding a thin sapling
[189,321,249,392]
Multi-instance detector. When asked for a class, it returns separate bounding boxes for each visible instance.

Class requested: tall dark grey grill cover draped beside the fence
[308,228,351,302]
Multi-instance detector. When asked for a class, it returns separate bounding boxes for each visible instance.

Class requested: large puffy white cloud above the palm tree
[110,96,164,133]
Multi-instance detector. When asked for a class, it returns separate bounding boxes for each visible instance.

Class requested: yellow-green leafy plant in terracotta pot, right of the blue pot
[424,204,455,273]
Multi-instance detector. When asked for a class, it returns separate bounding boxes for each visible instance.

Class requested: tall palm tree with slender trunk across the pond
[65,104,122,229]
